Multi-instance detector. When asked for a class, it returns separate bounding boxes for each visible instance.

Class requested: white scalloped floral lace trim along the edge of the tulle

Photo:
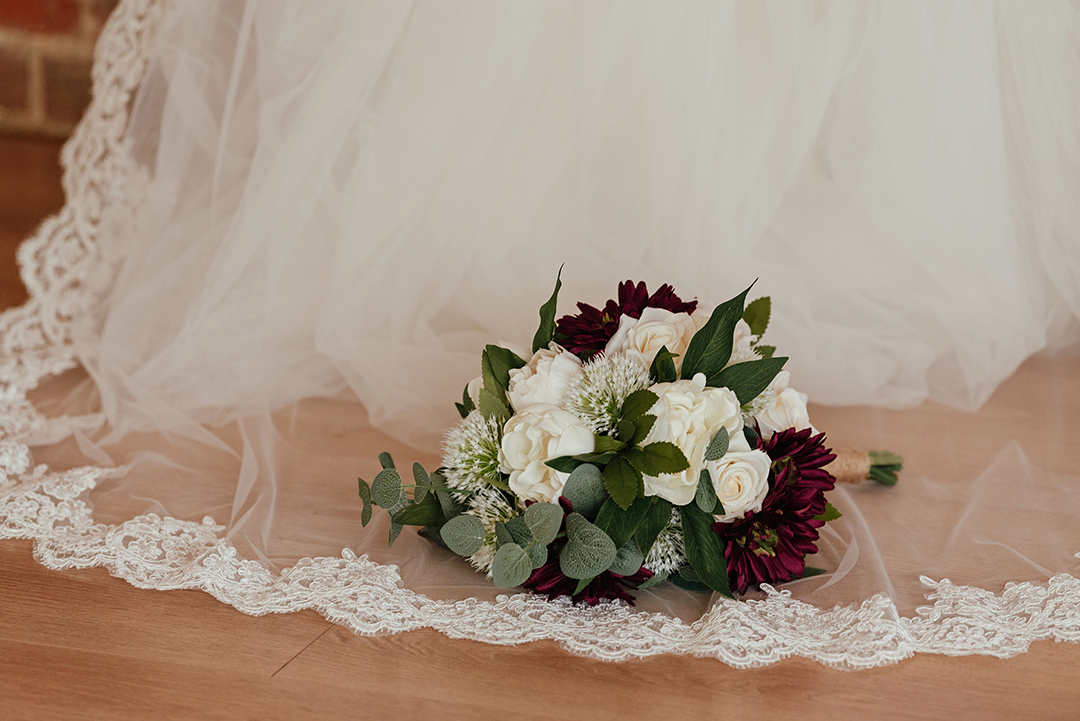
[0,0,1080,668]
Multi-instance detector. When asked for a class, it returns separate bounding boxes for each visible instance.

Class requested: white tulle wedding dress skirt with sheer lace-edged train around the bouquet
[0,0,1080,666]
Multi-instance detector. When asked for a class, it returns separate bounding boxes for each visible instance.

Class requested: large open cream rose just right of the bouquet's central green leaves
[645,373,743,506]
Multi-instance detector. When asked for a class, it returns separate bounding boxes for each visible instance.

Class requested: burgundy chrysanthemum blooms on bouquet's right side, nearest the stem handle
[713,428,836,593]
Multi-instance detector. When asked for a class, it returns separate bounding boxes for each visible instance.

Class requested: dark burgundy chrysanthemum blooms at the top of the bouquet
[555,281,698,359]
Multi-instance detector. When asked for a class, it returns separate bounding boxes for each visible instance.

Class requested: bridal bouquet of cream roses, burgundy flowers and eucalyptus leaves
[360,274,901,604]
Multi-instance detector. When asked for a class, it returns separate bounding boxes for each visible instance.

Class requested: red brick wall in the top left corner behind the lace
[0,0,118,137]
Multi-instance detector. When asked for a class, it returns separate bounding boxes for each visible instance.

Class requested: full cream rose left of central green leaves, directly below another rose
[499,404,596,503]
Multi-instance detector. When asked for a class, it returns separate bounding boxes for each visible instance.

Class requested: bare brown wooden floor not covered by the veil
[0,131,1080,721]
